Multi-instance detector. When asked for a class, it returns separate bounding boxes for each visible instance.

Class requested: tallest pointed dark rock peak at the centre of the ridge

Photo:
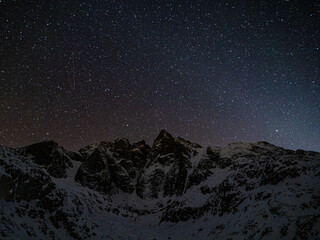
[137,130,201,199]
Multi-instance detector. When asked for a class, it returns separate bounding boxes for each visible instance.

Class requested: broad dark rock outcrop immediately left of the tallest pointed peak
[75,138,150,194]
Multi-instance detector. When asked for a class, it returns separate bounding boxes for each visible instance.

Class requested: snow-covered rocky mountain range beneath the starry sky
[0,130,320,239]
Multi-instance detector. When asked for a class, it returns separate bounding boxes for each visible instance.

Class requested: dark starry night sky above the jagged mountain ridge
[0,0,320,151]
